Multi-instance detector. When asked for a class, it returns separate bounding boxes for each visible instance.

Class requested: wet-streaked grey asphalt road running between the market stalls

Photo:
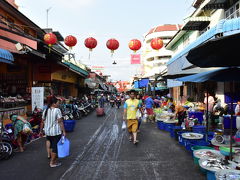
[0,107,205,180]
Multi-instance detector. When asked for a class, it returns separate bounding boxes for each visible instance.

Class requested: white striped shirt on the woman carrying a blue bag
[42,108,62,136]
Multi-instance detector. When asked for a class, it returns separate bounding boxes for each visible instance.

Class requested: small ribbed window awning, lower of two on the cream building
[182,16,210,31]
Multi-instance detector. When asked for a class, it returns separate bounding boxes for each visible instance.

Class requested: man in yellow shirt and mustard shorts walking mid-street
[123,90,141,144]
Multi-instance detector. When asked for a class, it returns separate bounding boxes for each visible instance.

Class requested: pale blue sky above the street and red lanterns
[16,0,193,80]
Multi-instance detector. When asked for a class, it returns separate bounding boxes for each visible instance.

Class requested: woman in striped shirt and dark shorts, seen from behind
[41,97,66,168]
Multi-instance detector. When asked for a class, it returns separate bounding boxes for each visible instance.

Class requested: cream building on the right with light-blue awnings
[166,0,240,103]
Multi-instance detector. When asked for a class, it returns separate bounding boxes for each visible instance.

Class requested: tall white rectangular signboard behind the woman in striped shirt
[32,87,44,111]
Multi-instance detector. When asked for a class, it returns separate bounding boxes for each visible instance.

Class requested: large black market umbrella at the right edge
[187,33,240,67]
